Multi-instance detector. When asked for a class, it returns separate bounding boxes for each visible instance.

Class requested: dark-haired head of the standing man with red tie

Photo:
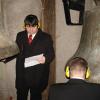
[24,14,39,34]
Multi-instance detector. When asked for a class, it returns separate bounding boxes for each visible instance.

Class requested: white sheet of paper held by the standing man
[24,54,43,68]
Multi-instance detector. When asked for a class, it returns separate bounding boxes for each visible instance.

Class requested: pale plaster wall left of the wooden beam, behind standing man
[0,0,42,100]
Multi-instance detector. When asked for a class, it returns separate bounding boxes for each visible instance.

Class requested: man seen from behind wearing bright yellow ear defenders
[48,57,100,100]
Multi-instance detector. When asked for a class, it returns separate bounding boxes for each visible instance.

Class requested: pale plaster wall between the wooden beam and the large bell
[56,0,94,83]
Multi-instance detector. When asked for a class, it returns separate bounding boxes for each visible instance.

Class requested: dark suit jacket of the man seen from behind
[49,79,100,100]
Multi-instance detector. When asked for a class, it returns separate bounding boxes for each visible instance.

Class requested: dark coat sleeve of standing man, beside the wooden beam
[44,36,55,63]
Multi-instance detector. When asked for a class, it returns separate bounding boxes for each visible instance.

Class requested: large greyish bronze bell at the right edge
[74,6,100,83]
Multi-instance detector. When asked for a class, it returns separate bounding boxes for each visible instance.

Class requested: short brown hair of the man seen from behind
[67,57,88,71]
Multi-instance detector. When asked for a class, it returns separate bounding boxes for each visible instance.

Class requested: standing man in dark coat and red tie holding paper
[4,14,55,100]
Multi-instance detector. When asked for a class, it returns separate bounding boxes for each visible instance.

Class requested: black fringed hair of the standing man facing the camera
[24,14,38,26]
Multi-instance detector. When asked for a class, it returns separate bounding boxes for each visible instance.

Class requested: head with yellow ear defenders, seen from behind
[66,57,90,79]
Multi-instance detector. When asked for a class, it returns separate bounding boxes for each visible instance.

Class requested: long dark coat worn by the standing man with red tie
[5,29,54,90]
